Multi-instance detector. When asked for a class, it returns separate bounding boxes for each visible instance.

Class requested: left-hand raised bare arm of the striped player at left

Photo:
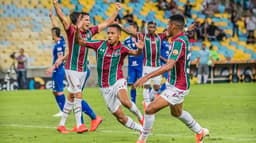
[52,0,70,30]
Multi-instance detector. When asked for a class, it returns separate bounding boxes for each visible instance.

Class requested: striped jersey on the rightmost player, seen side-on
[168,33,191,90]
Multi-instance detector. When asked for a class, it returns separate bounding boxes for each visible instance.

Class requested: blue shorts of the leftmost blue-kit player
[52,66,65,92]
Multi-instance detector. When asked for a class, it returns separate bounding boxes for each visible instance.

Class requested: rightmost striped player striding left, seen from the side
[135,15,209,143]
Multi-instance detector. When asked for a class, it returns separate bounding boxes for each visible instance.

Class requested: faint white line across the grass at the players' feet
[0,124,256,141]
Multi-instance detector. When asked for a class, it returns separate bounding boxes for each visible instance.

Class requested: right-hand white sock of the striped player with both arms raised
[74,98,82,128]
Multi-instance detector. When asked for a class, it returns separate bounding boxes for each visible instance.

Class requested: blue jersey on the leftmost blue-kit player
[52,36,66,66]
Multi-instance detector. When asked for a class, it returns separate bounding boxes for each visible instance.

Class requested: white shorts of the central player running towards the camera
[100,79,127,113]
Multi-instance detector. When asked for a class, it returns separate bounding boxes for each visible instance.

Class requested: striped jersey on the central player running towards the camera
[86,40,130,88]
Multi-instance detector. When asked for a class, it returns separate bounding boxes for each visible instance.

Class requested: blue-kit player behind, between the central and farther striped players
[123,23,143,104]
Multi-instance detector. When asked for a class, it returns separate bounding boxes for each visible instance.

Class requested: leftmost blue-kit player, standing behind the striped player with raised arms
[47,11,66,117]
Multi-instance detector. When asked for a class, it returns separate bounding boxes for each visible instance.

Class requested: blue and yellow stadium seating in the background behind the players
[0,0,256,69]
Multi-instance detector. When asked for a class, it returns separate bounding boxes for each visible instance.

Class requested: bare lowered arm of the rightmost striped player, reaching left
[134,59,176,87]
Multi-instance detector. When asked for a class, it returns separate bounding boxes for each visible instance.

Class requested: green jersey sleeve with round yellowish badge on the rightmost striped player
[169,41,183,61]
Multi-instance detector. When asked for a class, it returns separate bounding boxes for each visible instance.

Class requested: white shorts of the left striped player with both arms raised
[65,70,87,93]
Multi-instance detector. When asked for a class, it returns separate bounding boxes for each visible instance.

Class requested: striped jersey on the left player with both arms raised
[65,25,99,72]
